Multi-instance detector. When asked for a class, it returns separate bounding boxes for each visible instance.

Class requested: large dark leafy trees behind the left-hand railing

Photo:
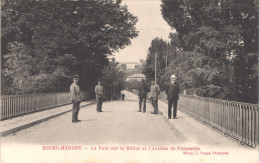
[1,0,138,94]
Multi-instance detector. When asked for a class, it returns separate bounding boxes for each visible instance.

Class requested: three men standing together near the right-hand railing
[138,75,180,119]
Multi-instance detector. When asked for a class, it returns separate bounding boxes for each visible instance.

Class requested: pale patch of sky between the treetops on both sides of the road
[114,0,174,63]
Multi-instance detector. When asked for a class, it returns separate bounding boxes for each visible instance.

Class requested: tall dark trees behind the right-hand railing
[143,0,259,103]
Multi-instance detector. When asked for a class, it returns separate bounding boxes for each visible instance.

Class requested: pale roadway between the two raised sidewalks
[4,91,184,145]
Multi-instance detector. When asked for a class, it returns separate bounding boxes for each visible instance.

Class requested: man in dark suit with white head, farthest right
[165,75,180,119]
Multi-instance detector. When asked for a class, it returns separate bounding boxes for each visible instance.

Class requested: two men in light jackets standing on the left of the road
[70,75,104,123]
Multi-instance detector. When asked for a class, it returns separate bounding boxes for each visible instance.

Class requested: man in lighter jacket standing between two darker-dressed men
[150,80,160,114]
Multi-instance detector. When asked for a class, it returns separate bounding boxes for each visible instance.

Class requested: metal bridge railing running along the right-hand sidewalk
[160,92,259,147]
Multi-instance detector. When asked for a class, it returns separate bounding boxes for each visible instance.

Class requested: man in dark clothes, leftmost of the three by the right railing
[138,79,148,113]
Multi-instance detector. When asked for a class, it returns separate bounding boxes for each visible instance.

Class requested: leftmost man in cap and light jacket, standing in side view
[70,75,81,123]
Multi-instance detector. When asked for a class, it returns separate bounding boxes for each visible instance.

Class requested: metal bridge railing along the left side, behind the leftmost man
[1,92,88,120]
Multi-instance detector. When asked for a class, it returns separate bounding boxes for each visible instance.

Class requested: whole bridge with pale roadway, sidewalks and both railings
[0,91,259,162]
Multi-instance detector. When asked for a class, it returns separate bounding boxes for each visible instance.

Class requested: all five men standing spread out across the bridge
[70,75,180,123]
